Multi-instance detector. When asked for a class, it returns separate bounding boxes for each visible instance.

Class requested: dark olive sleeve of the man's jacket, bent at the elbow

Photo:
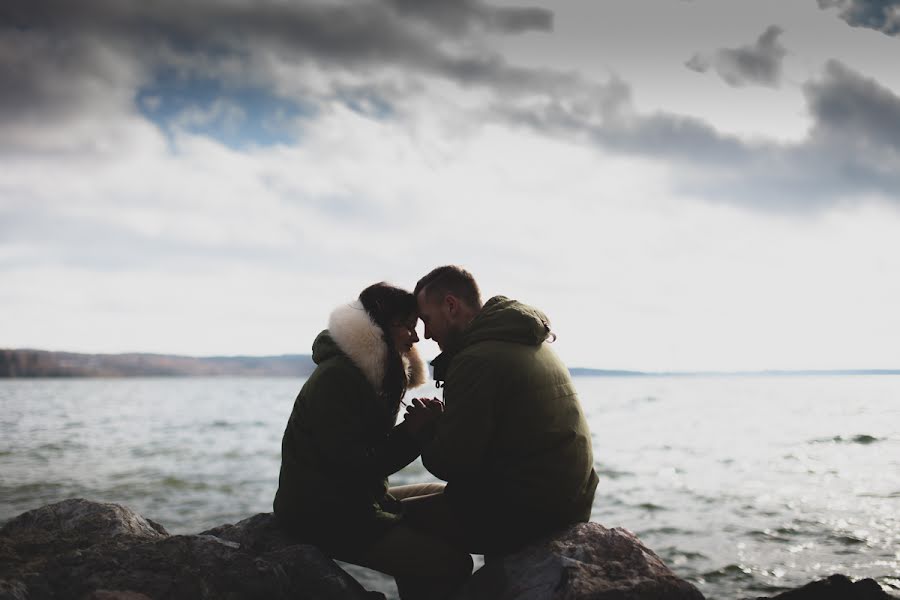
[422,356,499,481]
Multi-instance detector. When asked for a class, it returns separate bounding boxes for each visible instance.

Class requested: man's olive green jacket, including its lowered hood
[422,297,597,548]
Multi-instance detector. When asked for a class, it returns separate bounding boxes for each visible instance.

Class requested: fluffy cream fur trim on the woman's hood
[313,300,425,392]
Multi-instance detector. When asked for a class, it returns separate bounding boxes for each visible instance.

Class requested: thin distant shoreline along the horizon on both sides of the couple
[0,349,900,379]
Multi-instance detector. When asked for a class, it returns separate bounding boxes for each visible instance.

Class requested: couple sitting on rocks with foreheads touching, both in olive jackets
[274,266,597,600]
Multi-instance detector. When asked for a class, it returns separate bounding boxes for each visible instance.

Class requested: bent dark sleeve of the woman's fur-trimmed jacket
[310,372,421,479]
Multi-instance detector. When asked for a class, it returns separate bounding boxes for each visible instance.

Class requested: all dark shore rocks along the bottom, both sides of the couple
[0,499,891,600]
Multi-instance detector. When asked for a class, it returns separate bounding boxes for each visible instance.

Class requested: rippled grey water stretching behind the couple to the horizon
[0,376,900,599]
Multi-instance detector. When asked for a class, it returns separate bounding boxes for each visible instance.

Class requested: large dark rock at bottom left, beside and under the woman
[0,499,380,600]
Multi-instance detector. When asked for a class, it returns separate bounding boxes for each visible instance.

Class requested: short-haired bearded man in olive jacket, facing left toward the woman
[408,266,597,554]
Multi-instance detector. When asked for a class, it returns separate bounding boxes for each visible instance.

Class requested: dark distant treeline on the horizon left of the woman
[0,349,315,378]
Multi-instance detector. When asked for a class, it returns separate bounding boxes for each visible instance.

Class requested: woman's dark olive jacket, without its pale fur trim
[274,330,420,553]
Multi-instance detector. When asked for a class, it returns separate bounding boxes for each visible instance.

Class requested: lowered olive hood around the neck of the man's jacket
[431,296,553,381]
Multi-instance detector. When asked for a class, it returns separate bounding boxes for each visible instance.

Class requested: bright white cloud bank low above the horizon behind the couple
[0,94,900,369]
